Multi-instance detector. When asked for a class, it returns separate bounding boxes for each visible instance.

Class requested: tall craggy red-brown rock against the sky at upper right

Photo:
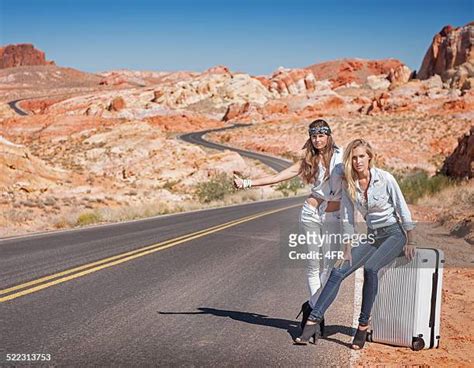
[417,22,474,87]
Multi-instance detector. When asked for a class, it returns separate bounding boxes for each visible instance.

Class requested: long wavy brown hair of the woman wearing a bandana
[298,119,337,184]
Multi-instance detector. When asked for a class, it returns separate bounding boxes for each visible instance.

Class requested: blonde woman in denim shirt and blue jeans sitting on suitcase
[295,139,415,349]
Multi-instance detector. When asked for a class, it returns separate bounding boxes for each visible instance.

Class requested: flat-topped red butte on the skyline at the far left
[0,44,55,69]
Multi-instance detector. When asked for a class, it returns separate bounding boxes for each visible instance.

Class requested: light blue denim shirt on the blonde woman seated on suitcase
[341,167,415,234]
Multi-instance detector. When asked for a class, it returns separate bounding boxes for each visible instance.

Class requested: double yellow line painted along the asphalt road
[0,204,301,303]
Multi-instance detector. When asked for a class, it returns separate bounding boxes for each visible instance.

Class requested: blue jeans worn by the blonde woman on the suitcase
[309,224,407,325]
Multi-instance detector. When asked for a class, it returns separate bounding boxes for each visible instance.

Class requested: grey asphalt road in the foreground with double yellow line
[0,126,354,367]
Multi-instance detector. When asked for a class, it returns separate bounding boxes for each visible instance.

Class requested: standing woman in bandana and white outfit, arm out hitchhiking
[234,119,344,335]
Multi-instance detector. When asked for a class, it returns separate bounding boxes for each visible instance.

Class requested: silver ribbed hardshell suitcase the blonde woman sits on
[367,248,444,350]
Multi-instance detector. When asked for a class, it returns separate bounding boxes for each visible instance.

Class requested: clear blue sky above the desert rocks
[0,0,474,74]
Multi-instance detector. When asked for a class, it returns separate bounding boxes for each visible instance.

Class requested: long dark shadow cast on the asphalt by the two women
[158,307,355,347]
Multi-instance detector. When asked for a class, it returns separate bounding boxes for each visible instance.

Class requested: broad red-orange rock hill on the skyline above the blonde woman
[306,59,403,88]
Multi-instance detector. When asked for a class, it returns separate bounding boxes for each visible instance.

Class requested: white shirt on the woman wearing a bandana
[311,147,344,202]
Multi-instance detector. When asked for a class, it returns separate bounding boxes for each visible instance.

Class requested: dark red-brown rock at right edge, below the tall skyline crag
[441,126,474,179]
